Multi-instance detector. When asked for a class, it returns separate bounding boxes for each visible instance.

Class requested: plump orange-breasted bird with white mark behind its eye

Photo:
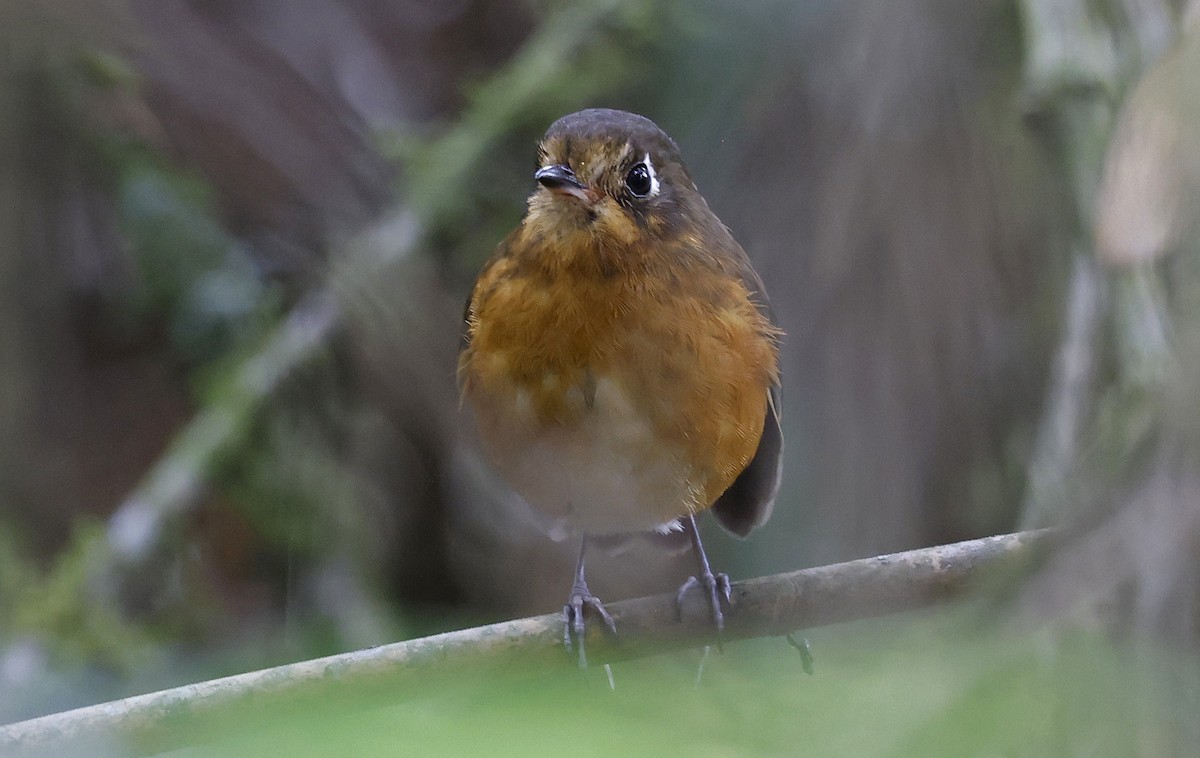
[457,108,784,668]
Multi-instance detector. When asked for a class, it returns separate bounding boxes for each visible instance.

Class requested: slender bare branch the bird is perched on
[0,530,1049,754]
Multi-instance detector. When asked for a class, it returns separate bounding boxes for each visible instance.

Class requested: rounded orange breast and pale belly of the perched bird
[460,231,778,533]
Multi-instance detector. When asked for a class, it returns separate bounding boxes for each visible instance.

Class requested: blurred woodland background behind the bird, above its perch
[0,0,1200,754]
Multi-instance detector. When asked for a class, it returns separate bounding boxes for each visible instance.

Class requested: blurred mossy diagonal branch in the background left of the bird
[88,0,657,609]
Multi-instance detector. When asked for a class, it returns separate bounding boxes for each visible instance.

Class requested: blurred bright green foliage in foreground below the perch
[119,610,1200,757]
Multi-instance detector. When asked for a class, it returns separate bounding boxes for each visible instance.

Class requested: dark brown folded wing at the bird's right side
[713,251,784,537]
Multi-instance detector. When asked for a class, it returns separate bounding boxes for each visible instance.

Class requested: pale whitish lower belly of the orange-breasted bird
[470,378,704,536]
